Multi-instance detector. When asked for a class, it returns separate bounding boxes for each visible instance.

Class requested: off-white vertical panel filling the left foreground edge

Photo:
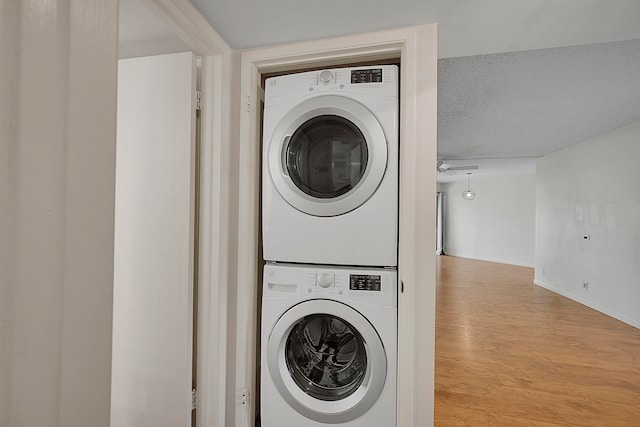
[0,0,118,427]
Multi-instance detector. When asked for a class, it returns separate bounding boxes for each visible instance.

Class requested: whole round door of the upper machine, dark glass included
[268,95,387,216]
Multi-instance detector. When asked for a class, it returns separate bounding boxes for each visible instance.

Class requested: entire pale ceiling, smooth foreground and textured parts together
[120,0,640,180]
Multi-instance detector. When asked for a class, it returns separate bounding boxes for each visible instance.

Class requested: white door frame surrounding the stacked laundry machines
[238,24,437,427]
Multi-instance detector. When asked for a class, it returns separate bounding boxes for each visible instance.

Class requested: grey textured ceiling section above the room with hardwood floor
[438,40,640,160]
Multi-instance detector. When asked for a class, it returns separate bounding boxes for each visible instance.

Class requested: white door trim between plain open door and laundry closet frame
[141,0,239,426]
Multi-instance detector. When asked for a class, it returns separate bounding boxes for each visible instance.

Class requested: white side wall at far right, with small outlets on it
[535,121,640,327]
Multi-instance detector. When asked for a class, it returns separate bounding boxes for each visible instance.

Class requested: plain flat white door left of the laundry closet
[111,52,195,427]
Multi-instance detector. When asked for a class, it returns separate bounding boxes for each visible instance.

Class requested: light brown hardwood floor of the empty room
[435,256,640,427]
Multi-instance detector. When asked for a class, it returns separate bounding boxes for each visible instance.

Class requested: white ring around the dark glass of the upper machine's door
[268,95,388,216]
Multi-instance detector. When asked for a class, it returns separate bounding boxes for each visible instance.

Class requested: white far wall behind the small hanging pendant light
[441,173,536,267]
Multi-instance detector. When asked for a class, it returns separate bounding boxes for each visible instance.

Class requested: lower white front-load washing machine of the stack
[260,264,398,427]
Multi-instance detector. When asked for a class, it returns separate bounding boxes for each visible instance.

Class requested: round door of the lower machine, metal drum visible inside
[266,299,387,424]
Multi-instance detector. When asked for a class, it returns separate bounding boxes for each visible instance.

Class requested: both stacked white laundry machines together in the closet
[261,65,399,427]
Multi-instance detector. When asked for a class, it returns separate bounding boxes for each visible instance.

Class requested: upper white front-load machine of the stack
[262,65,399,267]
